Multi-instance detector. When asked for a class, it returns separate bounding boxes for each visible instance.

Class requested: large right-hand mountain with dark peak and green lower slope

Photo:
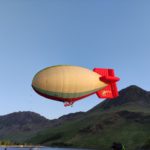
[28,86,150,150]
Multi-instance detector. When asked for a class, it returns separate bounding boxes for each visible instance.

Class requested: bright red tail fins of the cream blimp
[93,68,120,99]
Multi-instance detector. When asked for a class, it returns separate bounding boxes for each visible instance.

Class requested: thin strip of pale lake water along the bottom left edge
[0,147,91,150]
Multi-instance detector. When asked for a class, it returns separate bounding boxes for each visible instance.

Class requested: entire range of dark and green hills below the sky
[0,86,150,150]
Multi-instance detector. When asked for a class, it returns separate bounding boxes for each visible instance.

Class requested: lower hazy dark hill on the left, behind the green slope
[0,111,50,142]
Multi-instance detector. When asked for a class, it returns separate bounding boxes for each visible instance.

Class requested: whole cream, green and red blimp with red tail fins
[32,65,119,106]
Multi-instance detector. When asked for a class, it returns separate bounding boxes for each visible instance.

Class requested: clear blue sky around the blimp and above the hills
[0,0,150,119]
